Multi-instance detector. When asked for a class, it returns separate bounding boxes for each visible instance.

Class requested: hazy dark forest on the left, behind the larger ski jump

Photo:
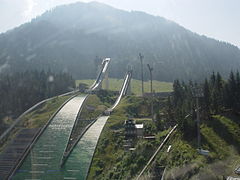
[0,70,75,130]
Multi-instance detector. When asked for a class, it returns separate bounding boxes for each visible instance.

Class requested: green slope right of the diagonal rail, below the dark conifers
[152,115,240,179]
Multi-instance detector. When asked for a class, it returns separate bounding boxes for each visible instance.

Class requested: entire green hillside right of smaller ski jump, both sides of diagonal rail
[88,94,240,179]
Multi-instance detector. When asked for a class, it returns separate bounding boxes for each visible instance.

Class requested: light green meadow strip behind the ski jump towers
[76,78,172,95]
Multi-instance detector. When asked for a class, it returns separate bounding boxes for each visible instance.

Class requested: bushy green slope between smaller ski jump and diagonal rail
[88,97,171,179]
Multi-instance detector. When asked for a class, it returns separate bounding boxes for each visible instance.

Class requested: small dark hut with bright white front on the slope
[124,119,143,139]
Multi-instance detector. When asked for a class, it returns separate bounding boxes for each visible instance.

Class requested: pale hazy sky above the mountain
[0,0,240,47]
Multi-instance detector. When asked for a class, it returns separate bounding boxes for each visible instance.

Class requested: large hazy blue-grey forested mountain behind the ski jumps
[0,2,240,81]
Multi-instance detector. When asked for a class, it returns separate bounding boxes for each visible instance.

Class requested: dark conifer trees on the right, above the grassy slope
[168,72,240,137]
